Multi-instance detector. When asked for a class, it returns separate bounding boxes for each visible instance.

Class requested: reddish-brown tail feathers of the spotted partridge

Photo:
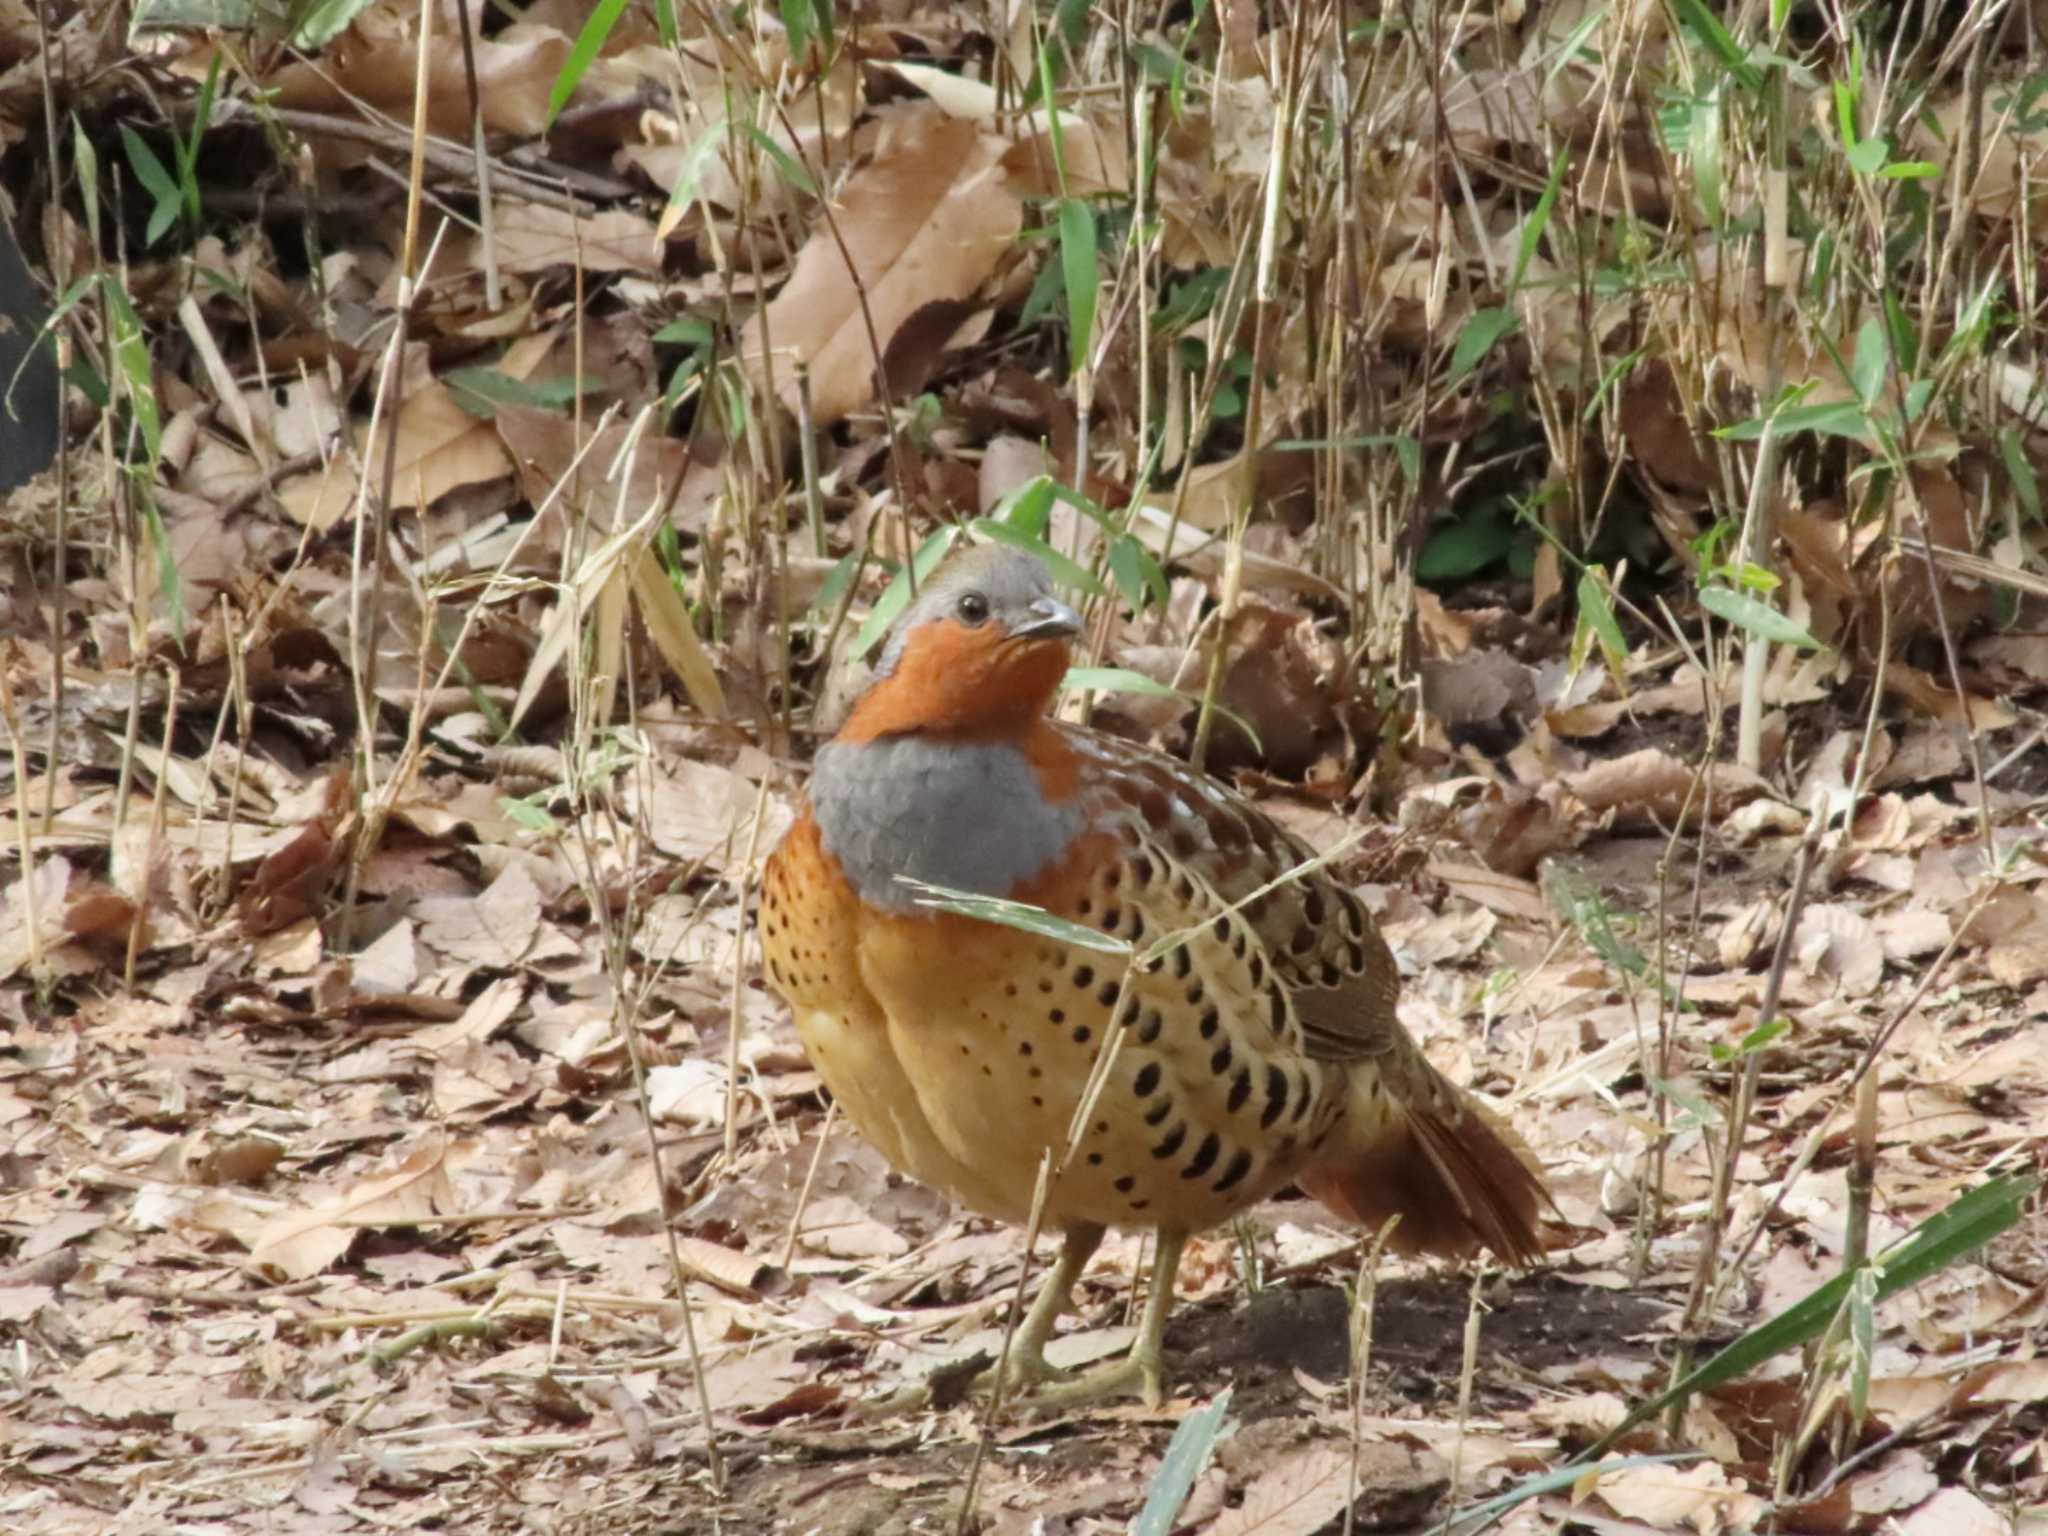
[1298,1079,1550,1264]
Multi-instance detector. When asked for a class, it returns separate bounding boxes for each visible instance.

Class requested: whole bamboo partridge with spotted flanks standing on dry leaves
[762,547,1544,1403]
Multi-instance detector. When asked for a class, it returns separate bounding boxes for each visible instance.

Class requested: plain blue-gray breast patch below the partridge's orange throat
[811,735,1083,911]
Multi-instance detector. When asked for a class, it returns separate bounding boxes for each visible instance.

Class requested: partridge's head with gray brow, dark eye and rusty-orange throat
[838,545,1081,743]
